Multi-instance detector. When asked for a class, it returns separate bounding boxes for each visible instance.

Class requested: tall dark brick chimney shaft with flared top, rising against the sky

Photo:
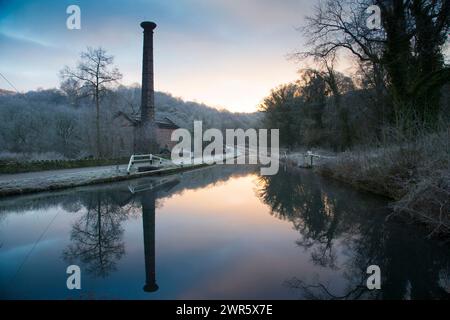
[141,21,156,125]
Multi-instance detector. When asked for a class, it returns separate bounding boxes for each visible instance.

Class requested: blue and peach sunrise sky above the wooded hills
[0,0,322,112]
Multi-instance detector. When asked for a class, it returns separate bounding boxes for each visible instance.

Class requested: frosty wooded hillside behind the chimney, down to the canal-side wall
[0,87,261,159]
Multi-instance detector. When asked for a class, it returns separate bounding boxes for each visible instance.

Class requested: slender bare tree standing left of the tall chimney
[60,47,122,157]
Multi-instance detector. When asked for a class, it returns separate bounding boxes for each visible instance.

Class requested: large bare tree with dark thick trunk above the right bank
[298,0,450,128]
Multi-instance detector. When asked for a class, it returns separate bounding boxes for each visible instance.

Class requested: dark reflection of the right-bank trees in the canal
[257,169,450,299]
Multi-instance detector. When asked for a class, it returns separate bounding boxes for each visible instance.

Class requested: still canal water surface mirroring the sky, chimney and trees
[0,166,450,299]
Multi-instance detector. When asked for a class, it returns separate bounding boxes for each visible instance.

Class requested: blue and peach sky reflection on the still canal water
[0,168,450,299]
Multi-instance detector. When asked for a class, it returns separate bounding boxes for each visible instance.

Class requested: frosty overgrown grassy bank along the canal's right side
[316,132,450,236]
